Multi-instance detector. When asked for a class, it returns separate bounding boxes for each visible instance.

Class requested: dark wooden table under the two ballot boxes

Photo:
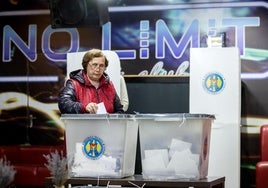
[46,175,225,188]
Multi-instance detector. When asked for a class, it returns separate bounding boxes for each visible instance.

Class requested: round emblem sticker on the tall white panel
[203,73,225,94]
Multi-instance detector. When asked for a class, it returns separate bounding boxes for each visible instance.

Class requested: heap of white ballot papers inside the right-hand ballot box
[142,139,199,179]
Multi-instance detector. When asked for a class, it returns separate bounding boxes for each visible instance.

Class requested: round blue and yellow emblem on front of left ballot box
[83,136,105,159]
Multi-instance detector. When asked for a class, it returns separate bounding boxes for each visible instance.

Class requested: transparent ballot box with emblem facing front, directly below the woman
[61,114,138,178]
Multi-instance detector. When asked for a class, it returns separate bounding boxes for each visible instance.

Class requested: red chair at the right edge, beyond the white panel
[256,125,268,188]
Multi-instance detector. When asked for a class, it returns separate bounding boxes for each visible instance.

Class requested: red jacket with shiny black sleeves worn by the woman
[58,70,124,114]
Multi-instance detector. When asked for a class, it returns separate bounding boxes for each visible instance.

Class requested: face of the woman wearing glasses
[87,57,106,81]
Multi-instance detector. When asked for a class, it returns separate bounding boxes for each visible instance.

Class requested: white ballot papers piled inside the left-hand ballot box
[72,143,120,177]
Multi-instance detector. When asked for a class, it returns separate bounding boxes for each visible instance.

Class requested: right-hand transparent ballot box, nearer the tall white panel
[136,114,214,179]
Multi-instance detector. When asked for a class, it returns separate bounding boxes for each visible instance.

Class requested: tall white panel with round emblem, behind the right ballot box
[190,48,241,188]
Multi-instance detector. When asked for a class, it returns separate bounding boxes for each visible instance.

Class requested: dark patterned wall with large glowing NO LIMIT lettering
[0,0,268,187]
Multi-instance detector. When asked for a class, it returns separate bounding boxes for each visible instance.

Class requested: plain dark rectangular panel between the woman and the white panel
[125,77,189,113]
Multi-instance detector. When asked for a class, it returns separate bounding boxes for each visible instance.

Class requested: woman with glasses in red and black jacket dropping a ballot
[58,49,124,114]
